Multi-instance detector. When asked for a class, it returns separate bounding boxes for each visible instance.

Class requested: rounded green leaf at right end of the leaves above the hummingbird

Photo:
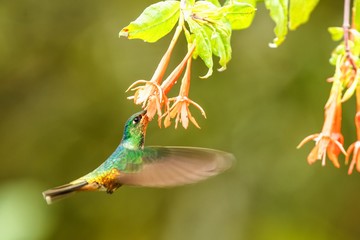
[221,1,256,30]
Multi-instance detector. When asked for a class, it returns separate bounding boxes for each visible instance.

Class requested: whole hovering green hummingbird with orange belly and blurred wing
[43,111,235,204]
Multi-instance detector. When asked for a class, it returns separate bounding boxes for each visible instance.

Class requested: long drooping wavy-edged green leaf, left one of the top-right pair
[265,0,289,48]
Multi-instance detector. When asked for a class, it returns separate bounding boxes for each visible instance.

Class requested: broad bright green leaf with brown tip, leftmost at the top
[119,1,180,42]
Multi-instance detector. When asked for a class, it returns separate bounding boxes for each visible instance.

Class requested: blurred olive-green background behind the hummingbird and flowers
[0,0,360,240]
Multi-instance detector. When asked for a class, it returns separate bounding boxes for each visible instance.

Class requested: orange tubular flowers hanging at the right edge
[298,29,360,174]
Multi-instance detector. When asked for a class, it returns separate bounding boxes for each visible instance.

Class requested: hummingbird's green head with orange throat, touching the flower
[122,110,149,149]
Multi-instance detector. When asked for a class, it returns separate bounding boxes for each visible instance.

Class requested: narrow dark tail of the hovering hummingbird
[43,180,88,204]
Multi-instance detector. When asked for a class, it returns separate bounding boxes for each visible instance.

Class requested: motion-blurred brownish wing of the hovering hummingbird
[119,147,235,187]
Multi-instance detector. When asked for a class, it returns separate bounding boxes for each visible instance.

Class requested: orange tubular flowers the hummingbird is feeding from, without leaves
[127,22,206,129]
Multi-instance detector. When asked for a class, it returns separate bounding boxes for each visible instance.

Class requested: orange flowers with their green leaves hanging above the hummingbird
[119,0,256,128]
